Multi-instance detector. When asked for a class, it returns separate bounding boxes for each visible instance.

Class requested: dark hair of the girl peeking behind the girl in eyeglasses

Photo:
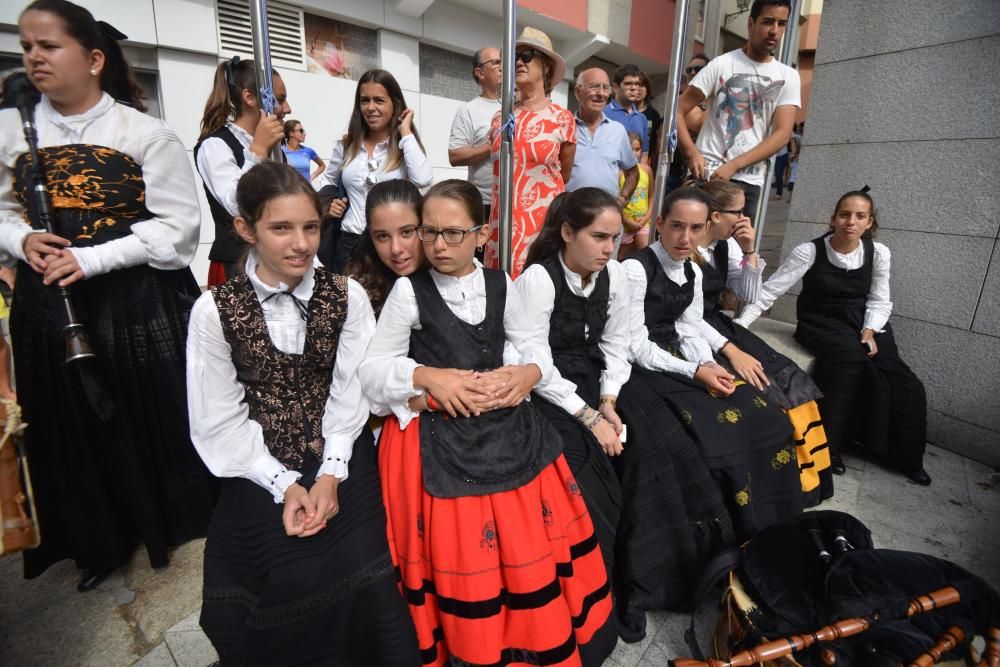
[344,178,421,316]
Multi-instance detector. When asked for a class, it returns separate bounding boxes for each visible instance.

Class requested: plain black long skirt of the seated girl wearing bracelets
[613,368,734,634]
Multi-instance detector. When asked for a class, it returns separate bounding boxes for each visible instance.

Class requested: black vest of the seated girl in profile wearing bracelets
[542,256,611,407]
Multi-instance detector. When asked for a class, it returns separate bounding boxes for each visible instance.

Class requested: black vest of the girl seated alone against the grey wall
[796,234,875,336]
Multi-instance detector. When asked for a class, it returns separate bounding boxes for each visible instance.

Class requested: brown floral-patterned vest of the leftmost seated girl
[212,268,347,469]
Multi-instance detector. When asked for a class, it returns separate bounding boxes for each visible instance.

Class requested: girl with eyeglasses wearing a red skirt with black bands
[360,180,615,667]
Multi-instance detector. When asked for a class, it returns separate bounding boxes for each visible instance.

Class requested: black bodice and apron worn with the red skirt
[409,269,563,498]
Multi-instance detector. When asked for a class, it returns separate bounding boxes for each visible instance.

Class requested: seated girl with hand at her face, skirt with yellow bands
[693,180,833,506]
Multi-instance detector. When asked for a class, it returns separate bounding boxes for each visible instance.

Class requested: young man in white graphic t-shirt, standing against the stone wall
[677,0,801,221]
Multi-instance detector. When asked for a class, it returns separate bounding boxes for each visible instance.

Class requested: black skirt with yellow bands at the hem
[705,311,834,507]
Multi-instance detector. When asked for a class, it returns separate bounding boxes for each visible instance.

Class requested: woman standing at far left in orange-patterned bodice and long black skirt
[0,0,213,591]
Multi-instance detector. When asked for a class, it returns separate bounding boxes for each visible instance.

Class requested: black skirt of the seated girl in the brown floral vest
[201,428,420,667]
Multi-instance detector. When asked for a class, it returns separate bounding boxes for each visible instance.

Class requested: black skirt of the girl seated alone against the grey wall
[795,325,927,470]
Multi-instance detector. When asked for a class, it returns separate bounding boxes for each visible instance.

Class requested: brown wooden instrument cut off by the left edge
[0,400,41,556]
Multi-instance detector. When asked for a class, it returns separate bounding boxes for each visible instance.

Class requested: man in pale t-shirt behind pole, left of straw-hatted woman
[448,46,503,227]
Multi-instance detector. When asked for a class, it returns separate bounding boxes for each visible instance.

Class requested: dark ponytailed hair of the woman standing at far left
[21,0,146,111]
